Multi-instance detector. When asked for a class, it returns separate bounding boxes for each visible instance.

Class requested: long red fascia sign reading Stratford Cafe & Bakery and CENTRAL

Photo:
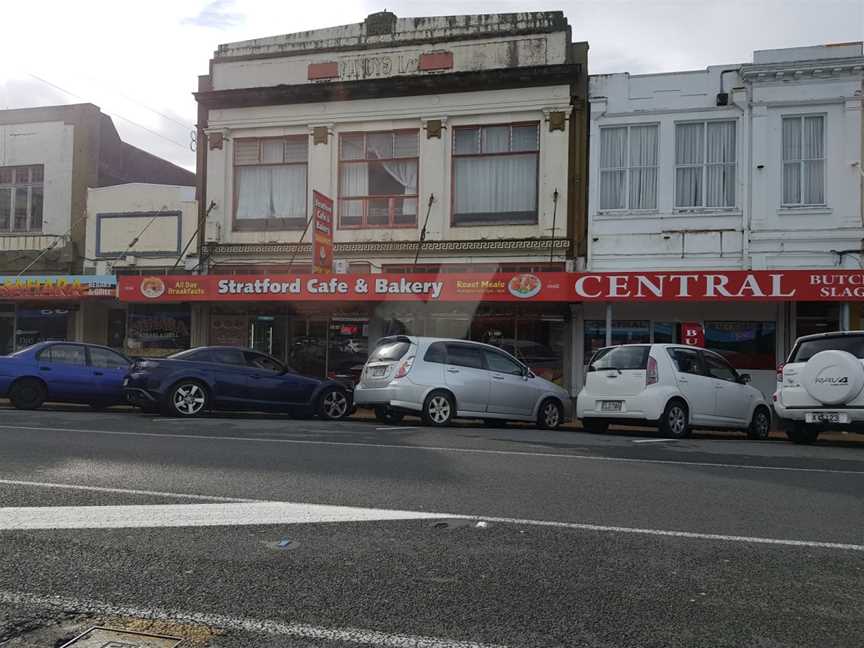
[118,270,864,302]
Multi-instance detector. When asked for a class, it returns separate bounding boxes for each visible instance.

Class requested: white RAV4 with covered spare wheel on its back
[774,331,864,443]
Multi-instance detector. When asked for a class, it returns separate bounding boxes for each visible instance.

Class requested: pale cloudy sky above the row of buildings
[0,0,864,170]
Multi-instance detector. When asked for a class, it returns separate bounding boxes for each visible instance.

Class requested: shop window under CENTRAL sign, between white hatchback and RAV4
[705,322,777,370]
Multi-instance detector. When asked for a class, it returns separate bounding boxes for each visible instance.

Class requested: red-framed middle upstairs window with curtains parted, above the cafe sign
[339,130,419,227]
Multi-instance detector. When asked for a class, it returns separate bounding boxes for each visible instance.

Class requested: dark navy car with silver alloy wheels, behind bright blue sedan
[125,346,351,420]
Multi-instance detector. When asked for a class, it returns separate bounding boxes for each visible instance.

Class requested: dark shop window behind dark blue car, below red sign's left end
[126,304,191,357]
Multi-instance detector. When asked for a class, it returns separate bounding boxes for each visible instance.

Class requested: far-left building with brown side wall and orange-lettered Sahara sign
[0,104,194,353]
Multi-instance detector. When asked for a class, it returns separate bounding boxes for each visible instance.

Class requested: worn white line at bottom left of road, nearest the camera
[0,590,505,648]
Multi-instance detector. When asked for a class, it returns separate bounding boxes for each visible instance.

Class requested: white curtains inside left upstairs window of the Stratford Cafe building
[236,164,306,220]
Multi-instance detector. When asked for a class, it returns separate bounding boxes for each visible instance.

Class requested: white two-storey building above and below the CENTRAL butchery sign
[581,43,864,393]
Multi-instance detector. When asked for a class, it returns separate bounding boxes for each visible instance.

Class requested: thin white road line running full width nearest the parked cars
[0,425,864,476]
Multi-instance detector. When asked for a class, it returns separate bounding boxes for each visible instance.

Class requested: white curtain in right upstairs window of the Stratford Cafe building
[454,153,537,221]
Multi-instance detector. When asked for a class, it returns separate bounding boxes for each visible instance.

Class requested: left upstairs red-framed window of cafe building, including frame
[234,135,309,230]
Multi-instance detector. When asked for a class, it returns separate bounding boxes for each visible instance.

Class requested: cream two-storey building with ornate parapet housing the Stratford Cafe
[170,12,587,382]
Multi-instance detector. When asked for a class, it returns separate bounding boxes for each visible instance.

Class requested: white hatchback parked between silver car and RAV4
[576,344,771,439]
